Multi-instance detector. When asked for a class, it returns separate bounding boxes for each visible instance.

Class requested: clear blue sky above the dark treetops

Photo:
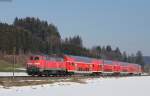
[0,0,150,55]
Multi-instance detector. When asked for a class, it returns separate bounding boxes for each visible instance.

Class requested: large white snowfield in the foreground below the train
[0,76,150,96]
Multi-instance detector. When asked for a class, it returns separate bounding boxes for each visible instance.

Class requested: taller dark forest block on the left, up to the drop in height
[0,17,60,54]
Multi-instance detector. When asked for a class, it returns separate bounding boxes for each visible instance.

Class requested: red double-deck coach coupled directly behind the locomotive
[65,56,102,74]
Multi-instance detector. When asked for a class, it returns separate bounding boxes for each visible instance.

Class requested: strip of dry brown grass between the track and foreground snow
[0,77,86,88]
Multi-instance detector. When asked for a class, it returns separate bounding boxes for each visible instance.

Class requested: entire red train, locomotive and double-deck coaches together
[27,55,142,76]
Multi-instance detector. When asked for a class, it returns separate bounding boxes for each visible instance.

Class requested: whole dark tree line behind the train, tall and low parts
[0,17,144,65]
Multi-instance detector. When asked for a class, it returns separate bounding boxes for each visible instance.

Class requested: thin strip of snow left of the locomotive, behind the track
[0,72,28,76]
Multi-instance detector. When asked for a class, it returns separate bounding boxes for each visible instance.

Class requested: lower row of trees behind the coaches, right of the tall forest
[62,36,144,66]
